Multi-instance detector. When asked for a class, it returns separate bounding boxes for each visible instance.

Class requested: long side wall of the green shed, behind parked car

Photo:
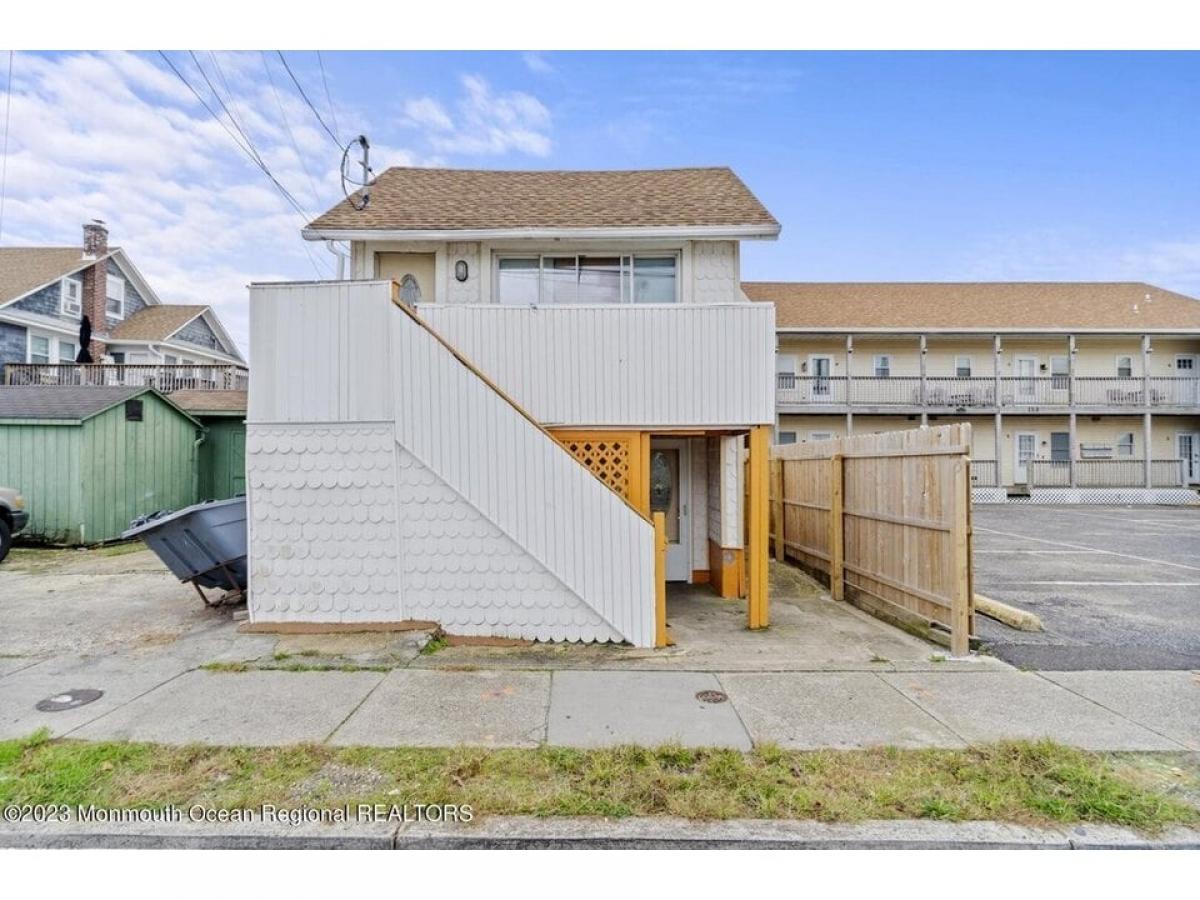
[0,422,83,544]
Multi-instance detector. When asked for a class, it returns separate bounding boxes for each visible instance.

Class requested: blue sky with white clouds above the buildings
[0,52,1200,352]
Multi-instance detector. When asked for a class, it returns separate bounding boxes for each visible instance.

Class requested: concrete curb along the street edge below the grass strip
[0,816,1200,850]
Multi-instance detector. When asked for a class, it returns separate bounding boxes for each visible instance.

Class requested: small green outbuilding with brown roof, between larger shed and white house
[169,390,246,500]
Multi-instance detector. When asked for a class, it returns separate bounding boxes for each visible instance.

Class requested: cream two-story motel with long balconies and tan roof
[742,282,1200,499]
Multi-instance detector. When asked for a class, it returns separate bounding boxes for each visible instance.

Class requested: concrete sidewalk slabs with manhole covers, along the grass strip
[0,647,1200,750]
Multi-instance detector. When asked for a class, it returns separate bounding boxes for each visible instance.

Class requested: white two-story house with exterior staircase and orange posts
[247,168,779,646]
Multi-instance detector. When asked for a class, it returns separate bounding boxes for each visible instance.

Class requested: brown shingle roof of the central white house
[308,168,779,233]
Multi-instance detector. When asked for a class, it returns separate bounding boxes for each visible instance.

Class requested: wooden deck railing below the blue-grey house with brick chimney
[4,362,250,394]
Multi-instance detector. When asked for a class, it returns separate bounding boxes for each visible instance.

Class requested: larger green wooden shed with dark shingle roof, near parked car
[0,385,205,545]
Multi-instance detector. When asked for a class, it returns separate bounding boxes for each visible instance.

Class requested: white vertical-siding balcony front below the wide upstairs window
[420,304,775,428]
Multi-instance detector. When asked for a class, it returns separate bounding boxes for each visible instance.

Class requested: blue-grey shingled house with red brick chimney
[0,222,245,376]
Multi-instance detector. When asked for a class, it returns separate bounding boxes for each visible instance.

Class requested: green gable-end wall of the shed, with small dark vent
[79,394,198,544]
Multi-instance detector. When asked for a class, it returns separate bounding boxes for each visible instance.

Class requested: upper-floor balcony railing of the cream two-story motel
[775,372,1200,410]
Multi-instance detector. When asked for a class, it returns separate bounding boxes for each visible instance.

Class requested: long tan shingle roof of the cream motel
[742,281,1200,331]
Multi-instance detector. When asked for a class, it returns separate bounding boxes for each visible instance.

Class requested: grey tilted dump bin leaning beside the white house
[121,497,246,606]
